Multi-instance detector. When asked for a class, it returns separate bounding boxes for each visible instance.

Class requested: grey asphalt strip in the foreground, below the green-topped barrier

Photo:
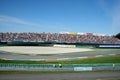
[0,72,120,80]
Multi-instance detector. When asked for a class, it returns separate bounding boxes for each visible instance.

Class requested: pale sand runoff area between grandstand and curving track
[0,46,93,54]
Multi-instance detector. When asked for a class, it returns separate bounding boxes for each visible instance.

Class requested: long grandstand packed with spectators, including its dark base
[0,32,120,48]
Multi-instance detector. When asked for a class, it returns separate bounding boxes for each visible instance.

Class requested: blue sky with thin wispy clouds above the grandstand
[0,0,120,35]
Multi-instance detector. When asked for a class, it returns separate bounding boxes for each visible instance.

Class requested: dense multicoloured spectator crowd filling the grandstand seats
[0,32,120,44]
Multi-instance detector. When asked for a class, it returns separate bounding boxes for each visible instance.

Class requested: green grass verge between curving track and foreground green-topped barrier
[0,55,120,64]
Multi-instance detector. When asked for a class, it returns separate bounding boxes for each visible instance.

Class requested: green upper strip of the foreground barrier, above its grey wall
[0,63,120,67]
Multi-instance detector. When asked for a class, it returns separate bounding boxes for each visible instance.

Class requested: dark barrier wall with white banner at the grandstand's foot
[0,41,120,49]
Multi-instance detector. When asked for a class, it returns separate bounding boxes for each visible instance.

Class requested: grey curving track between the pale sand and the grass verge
[0,50,120,60]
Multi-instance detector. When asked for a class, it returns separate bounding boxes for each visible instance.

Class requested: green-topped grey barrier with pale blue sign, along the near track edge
[0,63,120,71]
